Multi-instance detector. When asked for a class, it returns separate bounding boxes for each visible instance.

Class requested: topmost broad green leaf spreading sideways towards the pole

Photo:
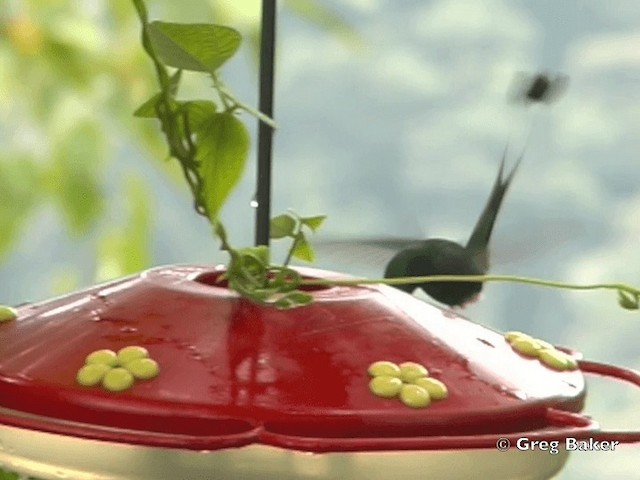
[149,22,241,72]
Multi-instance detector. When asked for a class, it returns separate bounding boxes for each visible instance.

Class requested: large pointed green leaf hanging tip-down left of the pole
[196,113,249,224]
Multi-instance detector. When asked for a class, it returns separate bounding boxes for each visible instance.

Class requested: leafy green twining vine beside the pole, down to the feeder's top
[133,0,325,308]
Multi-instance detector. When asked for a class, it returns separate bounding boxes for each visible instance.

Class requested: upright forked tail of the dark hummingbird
[465,146,524,272]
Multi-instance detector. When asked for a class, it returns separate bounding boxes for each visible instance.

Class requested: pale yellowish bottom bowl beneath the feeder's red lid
[0,426,569,480]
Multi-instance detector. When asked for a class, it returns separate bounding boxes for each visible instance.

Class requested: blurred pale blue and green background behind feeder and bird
[0,0,640,479]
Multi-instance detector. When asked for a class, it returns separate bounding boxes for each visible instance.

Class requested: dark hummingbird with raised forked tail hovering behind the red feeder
[384,148,524,308]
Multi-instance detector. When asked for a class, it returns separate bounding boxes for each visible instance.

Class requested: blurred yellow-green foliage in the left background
[0,0,357,293]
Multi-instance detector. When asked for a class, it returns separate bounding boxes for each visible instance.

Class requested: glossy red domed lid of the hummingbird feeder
[0,266,595,451]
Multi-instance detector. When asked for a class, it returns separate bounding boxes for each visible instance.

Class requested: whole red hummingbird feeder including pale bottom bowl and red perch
[0,266,640,480]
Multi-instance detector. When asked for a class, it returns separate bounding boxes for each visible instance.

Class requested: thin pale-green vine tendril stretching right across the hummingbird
[300,275,640,295]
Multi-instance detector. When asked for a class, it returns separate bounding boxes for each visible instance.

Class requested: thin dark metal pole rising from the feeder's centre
[255,0,276,245]
